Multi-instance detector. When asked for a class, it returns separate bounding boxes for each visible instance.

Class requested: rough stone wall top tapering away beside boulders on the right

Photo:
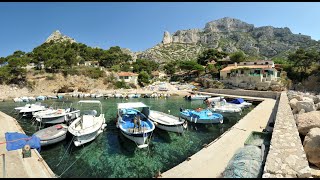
[262,92,311,178]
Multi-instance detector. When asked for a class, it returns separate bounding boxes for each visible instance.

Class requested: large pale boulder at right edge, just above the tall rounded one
[296,111,320,135]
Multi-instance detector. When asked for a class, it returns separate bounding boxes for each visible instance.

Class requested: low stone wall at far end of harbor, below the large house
[202,88,280,99]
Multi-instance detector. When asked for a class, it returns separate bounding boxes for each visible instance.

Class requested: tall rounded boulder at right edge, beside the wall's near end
[303,128,320,167]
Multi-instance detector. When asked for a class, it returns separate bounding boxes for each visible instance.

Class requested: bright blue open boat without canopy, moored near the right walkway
[180,108,223,124]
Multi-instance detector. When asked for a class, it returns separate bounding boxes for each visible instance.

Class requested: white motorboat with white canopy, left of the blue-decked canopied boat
[68,100,107,146]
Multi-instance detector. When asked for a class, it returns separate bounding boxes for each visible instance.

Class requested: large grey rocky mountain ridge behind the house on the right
[137,17,320,62]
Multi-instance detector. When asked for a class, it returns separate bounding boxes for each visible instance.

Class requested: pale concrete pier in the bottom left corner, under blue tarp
[0,111,55,178]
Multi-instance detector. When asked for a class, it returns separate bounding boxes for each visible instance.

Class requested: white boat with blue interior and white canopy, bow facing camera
[117,102,155,148]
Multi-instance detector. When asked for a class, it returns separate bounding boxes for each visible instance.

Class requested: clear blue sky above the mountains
[0,2,320,57]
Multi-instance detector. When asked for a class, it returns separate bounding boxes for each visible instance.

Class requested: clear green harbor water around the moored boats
[0,97,255,178]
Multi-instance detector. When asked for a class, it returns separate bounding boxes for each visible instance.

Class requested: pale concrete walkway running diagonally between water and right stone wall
[162,98,276,178]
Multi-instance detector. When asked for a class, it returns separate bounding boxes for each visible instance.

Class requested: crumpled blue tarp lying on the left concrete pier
[5,132,41,152]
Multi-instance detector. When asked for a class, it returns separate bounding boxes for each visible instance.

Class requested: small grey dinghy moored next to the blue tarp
[34,124,68,146]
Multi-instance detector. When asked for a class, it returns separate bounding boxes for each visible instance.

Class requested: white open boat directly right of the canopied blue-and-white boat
[148,110,187,133]
